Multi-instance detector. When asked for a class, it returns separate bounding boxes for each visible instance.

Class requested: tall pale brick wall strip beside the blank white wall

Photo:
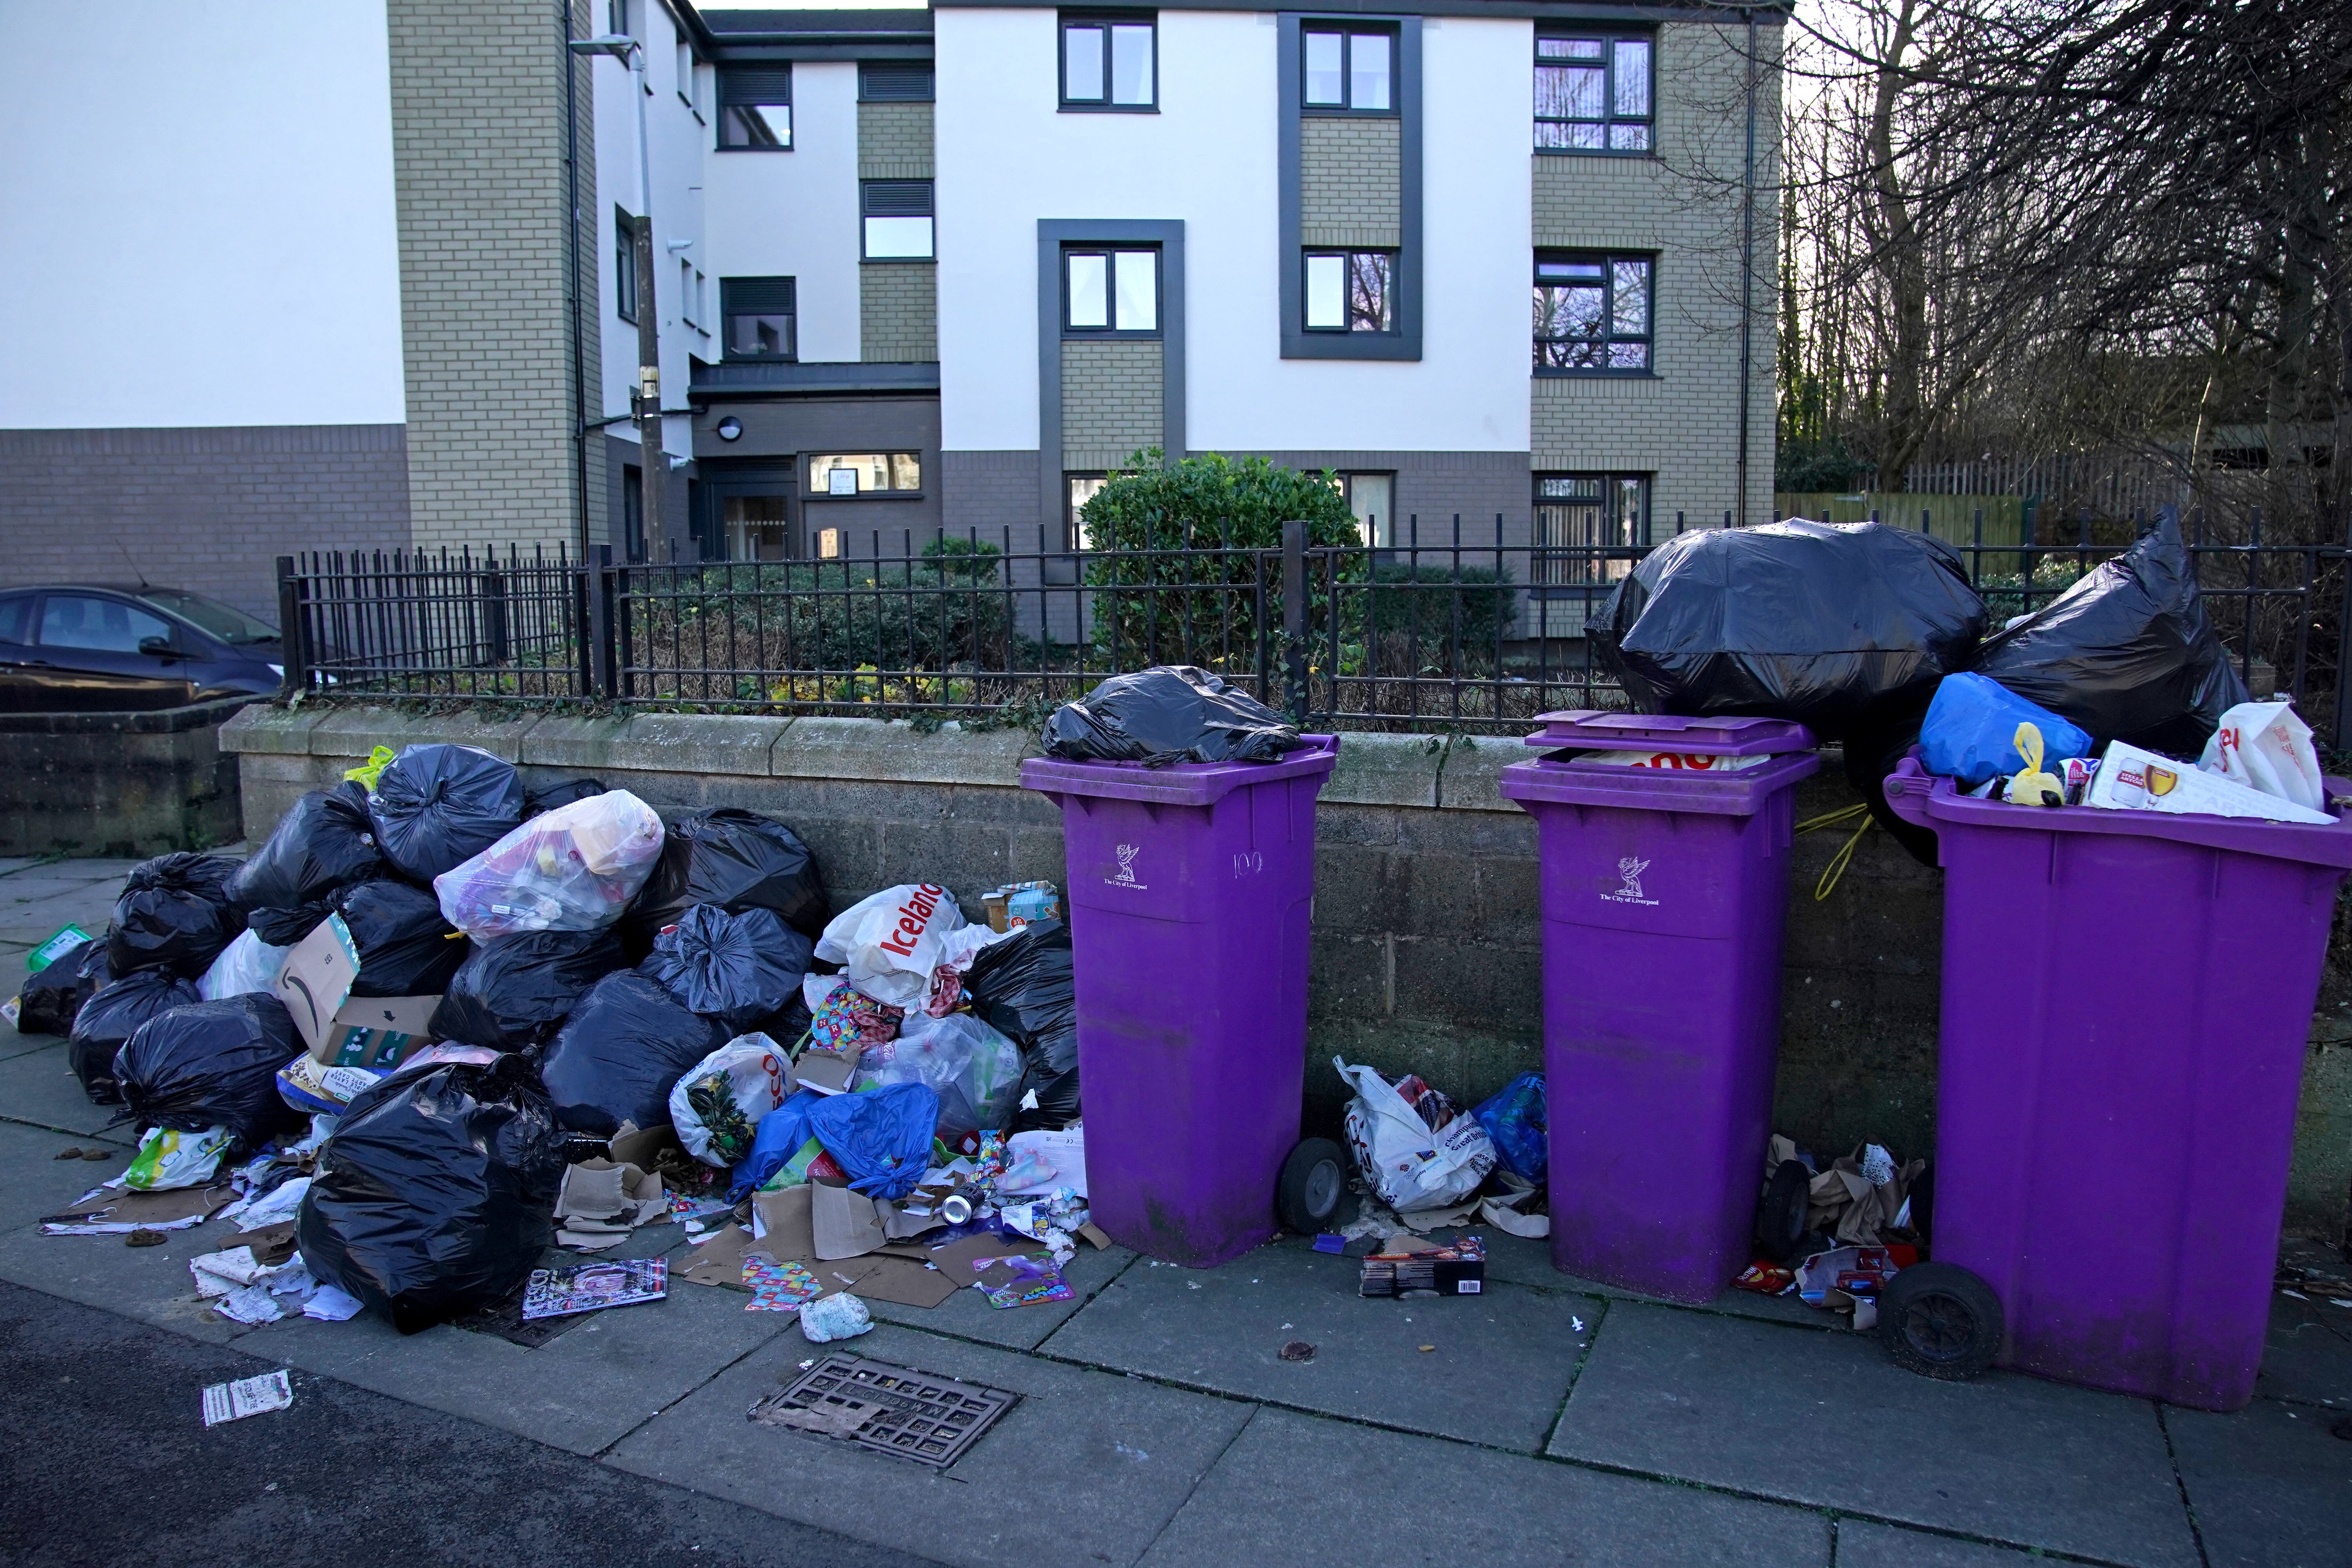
[386,0,593,545]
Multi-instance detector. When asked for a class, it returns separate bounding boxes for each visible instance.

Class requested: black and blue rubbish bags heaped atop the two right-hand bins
[1592,508,2267,865]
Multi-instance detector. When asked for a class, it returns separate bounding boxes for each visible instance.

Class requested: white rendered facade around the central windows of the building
[936,9,1534,451]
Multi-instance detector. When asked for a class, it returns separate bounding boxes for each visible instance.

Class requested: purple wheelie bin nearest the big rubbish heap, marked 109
[1021,736,1338,1269]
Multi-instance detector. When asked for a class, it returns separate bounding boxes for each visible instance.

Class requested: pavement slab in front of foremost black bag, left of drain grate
[238,1283,797,1453]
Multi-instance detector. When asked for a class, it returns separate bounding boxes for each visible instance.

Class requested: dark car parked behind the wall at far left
[0,583,285,712]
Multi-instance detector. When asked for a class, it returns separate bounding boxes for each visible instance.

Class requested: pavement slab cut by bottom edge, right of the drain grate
[1143,1410,1830,1568]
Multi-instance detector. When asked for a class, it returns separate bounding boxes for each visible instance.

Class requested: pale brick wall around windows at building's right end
[1531,24,1780,536]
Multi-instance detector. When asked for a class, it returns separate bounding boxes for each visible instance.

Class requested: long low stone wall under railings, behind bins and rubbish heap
[221,705,2352,1239]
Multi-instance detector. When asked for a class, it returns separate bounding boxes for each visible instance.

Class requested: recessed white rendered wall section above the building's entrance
[706,61,875,364]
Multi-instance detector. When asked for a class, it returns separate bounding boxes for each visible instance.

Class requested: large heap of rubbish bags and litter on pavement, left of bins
[14,745,1101,1333]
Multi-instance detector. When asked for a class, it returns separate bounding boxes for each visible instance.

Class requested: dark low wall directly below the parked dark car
[0,698,253,856]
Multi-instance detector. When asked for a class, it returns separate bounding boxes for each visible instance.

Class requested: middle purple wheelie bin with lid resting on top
[1501,712,1820,1302]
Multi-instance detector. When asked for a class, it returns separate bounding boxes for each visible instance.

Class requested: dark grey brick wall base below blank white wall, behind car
[0,425,409,623]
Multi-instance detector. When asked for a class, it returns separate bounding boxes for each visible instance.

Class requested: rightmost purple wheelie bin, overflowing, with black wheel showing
[1879,759,2352,1410]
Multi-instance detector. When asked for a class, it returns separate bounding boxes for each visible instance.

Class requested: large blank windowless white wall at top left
[0,0,405,430]
